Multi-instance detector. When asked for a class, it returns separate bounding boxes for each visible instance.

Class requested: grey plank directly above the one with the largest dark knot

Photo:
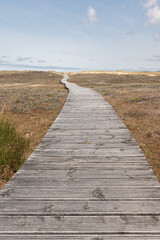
[7,177,159,188]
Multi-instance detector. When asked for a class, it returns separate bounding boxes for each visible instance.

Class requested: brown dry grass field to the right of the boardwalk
[70,72,160,180]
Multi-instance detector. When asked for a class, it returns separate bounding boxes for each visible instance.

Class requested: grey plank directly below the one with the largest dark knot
[0,199,160,216]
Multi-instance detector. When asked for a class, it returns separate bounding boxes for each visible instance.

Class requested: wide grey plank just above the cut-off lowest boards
[0,214,160,234]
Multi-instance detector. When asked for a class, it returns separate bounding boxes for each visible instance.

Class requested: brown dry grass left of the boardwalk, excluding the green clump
[0,71,68,189]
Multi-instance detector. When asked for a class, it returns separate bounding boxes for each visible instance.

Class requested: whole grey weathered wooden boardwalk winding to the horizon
[0,77,160,240]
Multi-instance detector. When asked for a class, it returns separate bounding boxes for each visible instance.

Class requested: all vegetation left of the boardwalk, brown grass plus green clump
[0,71,68,188]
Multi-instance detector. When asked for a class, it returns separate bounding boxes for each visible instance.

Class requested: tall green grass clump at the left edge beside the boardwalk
[0,119,29,173]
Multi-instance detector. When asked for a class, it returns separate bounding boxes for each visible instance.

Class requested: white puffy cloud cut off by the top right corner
[144,0,160,24]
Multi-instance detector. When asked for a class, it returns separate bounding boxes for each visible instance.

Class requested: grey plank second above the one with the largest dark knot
[15,168,155,179]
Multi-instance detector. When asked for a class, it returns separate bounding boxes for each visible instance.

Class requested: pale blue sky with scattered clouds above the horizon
[0,0,160,71]
